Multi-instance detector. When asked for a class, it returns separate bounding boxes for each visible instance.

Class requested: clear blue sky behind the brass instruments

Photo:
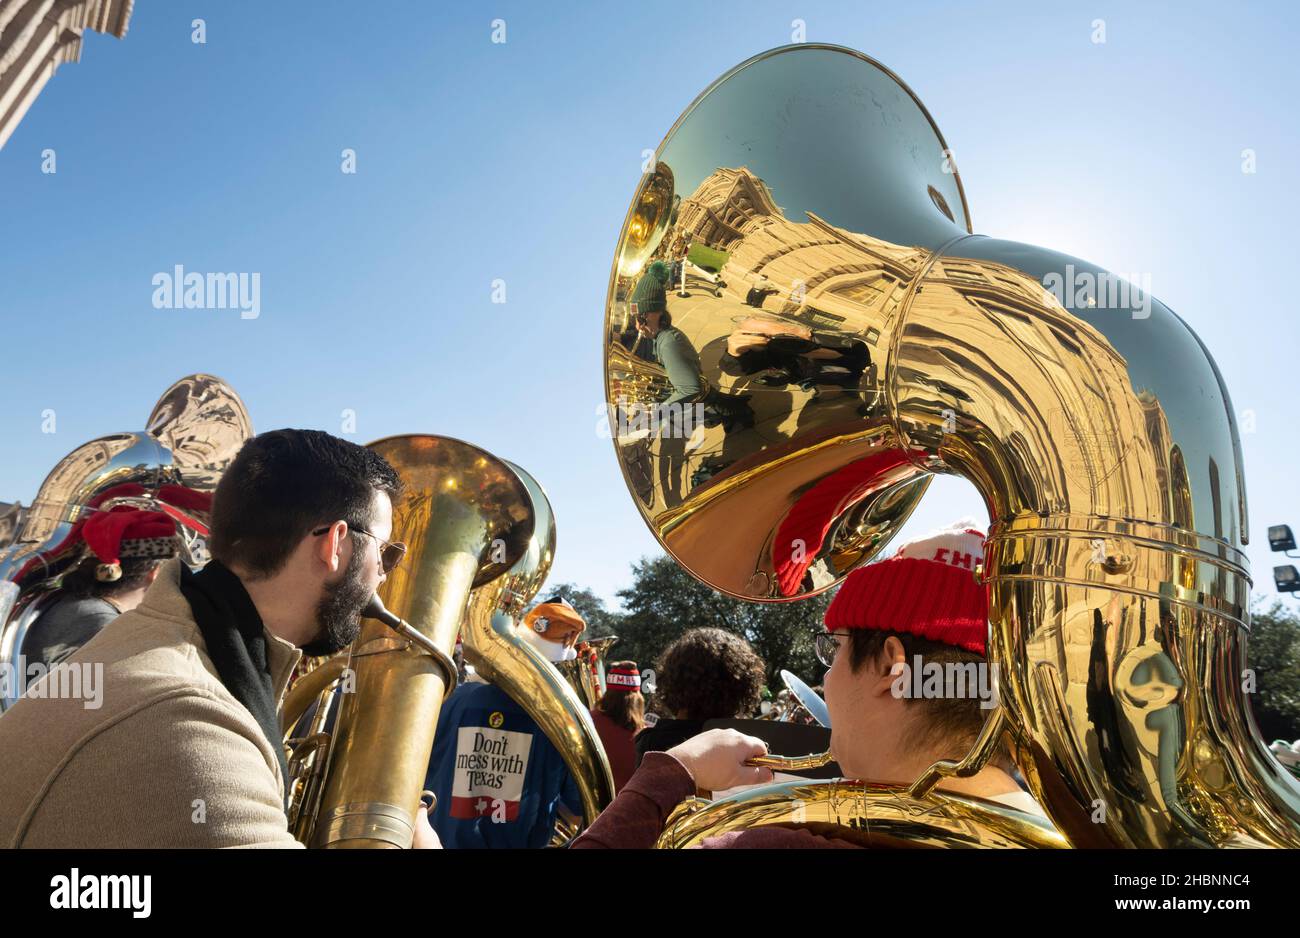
[0,0,1300,599]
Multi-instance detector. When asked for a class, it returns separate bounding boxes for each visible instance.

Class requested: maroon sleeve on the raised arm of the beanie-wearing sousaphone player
[571,752,696,850]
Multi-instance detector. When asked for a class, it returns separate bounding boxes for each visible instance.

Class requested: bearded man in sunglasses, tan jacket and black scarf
[0,430,437,848]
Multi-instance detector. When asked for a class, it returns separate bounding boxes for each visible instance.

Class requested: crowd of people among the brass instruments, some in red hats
[0,430,1041,848]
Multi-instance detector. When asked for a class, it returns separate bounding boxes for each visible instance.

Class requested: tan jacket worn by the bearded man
[0,560,302,847]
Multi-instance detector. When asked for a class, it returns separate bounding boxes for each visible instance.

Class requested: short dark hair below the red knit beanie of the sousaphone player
[849,629,1008,765]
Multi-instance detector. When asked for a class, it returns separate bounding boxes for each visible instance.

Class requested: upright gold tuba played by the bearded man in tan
[281,435,534,847]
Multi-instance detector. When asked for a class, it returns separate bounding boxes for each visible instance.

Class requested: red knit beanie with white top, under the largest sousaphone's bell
[826,521,988,655]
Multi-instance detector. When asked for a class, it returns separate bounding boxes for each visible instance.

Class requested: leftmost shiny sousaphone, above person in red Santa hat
[0,374,252,709]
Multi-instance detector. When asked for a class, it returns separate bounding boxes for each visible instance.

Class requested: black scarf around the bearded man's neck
[181,560,289,796]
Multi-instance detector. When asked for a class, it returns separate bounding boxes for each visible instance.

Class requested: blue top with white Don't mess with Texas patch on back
[425,682,582,848]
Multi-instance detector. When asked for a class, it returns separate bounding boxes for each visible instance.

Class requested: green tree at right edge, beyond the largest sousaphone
[1247,600,1300,742]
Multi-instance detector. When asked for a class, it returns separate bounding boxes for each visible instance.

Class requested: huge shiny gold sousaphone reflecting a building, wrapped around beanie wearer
[605,43,1300,847]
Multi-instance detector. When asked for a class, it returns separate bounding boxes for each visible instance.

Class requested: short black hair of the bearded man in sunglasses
[208,430,402,577]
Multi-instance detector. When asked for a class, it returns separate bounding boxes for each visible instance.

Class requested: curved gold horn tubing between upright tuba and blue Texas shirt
[462,463,614,825]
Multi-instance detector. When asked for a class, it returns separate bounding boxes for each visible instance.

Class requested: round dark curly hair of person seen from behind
[655,629,764,720]
